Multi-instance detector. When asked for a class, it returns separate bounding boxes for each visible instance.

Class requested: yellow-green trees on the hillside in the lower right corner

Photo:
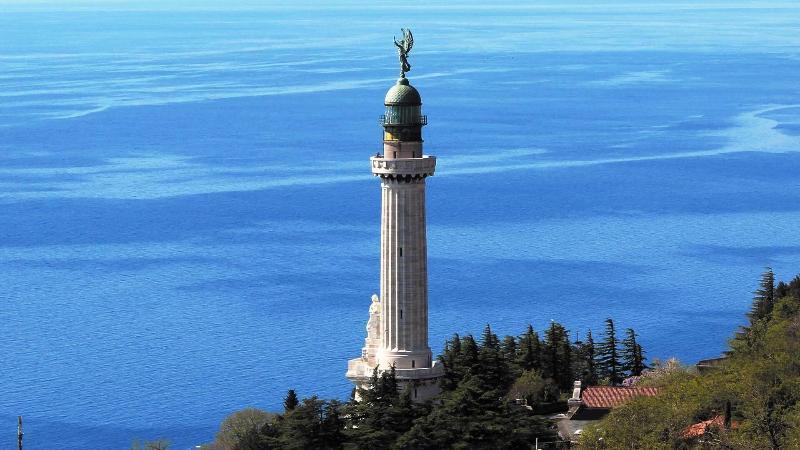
[580,270,800,449]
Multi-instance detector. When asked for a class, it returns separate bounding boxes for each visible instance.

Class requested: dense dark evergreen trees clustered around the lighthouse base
[215,322,644,450]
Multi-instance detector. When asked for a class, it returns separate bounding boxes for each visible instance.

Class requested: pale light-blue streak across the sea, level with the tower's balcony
[0,105,800,201]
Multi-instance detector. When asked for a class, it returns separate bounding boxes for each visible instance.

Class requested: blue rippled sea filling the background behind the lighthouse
[0,0,800,449]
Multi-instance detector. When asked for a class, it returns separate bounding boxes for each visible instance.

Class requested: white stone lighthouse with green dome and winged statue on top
[347,30,444,401]
